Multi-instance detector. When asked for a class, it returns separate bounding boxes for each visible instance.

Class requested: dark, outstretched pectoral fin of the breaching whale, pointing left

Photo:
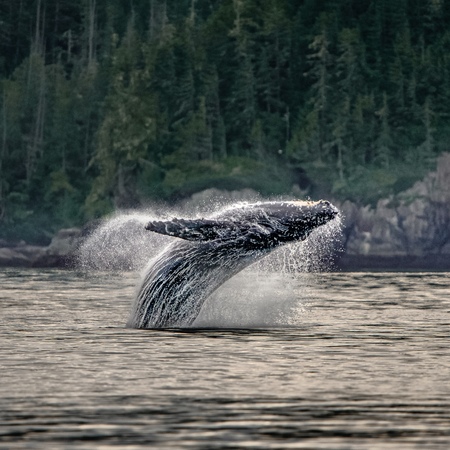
[145,219,241,241]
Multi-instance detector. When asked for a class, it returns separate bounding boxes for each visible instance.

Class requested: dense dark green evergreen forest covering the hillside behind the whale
[0,0,450,242]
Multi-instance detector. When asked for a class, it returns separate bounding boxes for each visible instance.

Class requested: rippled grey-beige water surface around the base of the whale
[0,270,450,449]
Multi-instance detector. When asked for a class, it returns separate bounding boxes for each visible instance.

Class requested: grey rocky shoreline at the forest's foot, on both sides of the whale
[0,153,450,271]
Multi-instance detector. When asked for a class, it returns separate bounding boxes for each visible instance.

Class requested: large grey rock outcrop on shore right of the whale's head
[340,153,450,268]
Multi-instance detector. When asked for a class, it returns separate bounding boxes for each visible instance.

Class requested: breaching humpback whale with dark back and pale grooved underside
[127,200,338,328]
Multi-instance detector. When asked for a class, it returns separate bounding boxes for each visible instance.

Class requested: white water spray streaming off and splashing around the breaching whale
[79,200,341,327]
